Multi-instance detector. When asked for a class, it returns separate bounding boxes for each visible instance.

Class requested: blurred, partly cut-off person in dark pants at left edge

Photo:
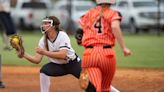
[0,0,16,50]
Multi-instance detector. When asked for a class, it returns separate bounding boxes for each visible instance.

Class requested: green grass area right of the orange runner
[116,35,164,68]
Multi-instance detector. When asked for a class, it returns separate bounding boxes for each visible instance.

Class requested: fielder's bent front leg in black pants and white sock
[40,62,66,92]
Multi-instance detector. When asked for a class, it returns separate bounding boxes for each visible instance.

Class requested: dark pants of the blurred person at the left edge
[0,11,16,35]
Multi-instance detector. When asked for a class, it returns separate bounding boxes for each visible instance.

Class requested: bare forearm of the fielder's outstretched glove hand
[23,53,43,64]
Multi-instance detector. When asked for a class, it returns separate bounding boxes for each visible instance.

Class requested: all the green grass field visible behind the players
[0,32,164,68]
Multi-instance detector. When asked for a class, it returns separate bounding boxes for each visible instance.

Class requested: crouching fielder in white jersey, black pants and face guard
[20,16,81,92]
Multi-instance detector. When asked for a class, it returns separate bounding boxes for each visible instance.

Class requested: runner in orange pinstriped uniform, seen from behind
[80,0,131,92]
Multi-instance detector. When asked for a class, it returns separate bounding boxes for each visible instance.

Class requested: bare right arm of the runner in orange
[111,20,131,56]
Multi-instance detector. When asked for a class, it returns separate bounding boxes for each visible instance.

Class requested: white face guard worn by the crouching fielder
[40,19,53,34]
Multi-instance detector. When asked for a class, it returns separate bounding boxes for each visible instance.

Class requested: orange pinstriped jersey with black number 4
[79,6,121,47]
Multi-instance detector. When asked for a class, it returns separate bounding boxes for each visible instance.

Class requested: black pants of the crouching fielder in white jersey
[40,59,96,92]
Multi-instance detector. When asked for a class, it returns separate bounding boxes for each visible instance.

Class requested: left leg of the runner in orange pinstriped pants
[80,48,102,92]
